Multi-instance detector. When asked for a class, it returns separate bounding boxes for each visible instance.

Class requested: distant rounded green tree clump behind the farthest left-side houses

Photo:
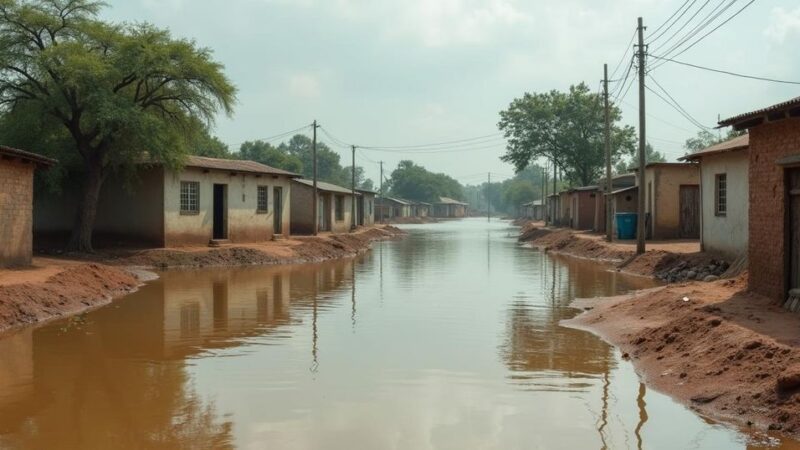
[389,160,464,202]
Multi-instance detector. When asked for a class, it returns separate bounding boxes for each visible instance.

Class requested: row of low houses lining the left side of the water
[0,146,388,266]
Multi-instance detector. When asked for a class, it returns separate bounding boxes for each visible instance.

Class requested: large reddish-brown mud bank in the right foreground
[562,276,800,438]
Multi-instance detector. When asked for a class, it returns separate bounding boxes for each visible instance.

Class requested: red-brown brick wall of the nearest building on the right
[748,119,800,300]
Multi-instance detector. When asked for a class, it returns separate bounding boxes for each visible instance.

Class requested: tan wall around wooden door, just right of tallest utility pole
[645,164,700,239]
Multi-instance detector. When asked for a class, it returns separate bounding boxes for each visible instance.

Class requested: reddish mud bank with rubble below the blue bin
[519,222,738,283]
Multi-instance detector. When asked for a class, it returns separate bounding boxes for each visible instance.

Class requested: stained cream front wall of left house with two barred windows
[163,167,293,246]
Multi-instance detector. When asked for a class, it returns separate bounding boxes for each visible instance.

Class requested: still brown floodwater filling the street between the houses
[0,219,798,450]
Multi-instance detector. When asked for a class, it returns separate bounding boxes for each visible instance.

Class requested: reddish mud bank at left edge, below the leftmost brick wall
[0,264,140,332]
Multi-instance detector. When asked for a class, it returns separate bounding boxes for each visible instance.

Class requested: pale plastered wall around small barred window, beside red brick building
[700,150,750,259]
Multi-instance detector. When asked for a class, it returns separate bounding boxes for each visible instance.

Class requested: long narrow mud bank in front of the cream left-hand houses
[103,225,406,269]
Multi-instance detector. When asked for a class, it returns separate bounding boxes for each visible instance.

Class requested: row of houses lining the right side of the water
[523,97,800,310]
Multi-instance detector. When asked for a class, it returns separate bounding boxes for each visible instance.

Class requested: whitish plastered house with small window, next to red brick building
[682,134,750,260]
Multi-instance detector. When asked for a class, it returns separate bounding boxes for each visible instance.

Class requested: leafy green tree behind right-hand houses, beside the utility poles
[498,83,635,185]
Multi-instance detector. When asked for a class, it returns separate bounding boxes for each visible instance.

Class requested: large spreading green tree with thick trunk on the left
[0,0,236,251]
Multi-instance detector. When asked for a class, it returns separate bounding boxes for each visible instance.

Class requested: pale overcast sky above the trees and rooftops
[104,0,800,184]
